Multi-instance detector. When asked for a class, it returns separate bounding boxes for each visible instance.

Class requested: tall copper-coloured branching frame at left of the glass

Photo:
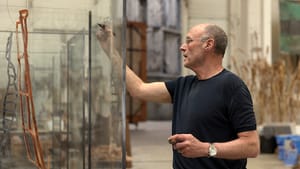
[16,9,46,169]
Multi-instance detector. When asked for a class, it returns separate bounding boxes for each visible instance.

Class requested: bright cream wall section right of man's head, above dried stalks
[229,0,272,62]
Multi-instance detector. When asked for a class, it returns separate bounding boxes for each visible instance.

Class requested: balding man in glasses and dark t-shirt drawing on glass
[98,24,259,169]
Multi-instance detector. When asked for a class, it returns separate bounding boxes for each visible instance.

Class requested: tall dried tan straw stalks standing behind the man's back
[232,57,300,124]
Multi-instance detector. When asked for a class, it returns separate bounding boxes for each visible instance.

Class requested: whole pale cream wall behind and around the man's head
[182,0,278,74]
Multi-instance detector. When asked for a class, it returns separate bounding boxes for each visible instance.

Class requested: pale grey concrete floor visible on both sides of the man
[130,121,292,169]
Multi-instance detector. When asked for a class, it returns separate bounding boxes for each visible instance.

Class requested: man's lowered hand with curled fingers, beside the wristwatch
[168,134,209,158]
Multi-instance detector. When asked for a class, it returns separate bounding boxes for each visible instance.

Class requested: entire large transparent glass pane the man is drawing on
[0,0,125,169]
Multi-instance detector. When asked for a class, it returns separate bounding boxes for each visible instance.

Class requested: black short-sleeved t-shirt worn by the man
[165,69,256,169]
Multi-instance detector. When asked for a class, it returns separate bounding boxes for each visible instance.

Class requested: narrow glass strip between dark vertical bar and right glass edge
[91,0,123,168]
